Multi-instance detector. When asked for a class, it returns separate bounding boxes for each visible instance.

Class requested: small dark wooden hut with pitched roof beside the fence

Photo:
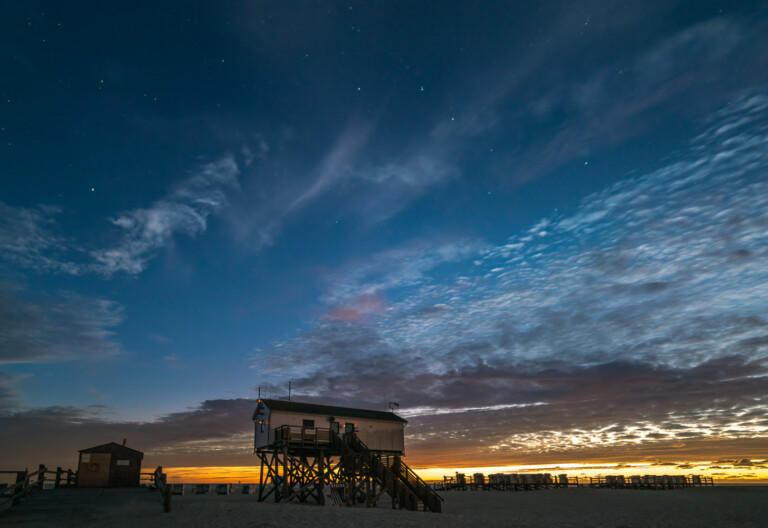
[77,440,144,488]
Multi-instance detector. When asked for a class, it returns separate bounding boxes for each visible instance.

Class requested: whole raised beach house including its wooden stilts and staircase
[253,399,443,512]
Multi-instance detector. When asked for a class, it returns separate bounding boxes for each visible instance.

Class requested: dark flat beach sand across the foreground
[0,486,768,528]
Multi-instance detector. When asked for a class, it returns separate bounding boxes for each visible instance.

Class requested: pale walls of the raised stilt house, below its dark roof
[254,411,405,453]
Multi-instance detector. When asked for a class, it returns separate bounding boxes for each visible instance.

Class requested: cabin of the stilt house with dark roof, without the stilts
[253,399,408,455]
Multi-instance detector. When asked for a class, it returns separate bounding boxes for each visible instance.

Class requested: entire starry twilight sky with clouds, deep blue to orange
[0,0,768,478]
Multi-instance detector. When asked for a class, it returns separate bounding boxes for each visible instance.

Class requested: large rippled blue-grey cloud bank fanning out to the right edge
[254,94,768,462]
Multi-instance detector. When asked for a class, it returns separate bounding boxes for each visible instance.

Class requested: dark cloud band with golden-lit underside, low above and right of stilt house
[266,318,768,462]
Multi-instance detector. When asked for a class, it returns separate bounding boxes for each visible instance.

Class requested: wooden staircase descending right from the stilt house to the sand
[336,433,443,513]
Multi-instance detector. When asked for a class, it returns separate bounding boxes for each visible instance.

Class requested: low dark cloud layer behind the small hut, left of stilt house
[0,399,256,467]
